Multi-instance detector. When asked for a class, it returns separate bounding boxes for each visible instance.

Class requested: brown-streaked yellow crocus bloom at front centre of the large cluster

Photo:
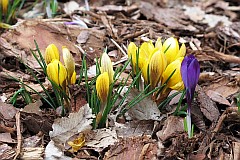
[149,50,167,88]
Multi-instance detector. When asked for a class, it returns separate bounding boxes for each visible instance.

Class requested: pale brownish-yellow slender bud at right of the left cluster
[62,46,76,84]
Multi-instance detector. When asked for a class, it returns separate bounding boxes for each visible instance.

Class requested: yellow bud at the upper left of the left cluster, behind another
[44,44,60,64]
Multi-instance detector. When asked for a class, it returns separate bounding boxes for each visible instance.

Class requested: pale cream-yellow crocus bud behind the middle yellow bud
[100,52,114,84]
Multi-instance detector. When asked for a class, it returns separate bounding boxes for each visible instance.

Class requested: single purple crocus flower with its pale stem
[181,55,200,137]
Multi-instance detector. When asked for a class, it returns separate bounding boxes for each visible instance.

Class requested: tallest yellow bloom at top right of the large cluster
[163,37,179,64]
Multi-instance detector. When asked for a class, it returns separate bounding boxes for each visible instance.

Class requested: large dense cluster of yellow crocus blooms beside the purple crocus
[128,37,186,94]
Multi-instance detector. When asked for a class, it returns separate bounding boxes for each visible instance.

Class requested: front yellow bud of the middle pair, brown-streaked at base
[96,72,109,104]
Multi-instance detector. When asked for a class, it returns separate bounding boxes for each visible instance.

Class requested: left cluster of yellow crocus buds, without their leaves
[44,44,76,90]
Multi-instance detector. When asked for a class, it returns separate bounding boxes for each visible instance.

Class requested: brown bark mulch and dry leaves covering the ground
[0,0,240,159]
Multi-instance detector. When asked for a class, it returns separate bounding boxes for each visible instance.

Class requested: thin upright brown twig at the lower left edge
[14,111,22,160]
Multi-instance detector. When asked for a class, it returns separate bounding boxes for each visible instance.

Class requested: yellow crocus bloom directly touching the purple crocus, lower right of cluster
[162,57,184,91]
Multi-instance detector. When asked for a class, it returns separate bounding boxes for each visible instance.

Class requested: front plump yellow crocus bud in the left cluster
[47,59,67,87]
